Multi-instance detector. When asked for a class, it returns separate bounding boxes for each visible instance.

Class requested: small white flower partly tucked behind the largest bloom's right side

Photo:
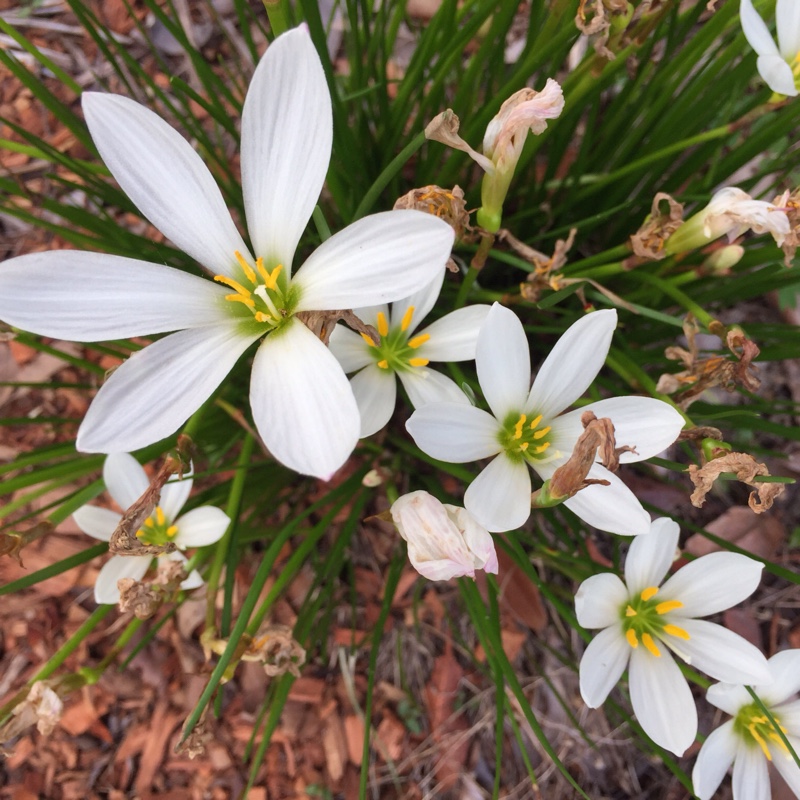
[330,270,489,436]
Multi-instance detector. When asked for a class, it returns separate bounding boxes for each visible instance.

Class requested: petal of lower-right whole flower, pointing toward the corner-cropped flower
[664,614,770,685]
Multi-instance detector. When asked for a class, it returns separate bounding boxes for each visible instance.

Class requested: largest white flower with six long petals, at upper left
[0,28,453,478]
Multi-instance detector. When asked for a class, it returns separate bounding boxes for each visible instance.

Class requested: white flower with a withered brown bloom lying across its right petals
[406,303,683,535]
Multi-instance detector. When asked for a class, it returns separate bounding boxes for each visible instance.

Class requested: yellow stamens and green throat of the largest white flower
[214,250,297,333]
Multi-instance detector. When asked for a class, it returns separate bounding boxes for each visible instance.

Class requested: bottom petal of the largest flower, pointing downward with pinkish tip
[250,320,361,480]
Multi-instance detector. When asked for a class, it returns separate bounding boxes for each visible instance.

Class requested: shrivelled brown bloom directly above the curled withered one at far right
[656,314,761,410]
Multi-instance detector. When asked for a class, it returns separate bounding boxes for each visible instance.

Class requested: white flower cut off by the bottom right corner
[692,650,800,800]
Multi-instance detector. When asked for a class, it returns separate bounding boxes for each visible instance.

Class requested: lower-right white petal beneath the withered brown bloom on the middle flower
[564,464,650,536]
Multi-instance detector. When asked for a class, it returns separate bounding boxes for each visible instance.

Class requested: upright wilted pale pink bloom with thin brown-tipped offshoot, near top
[425,83,564,233]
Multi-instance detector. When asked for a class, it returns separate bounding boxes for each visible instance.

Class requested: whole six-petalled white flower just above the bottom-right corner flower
[575,518,769,756]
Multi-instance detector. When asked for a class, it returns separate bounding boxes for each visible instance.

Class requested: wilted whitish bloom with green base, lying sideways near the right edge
[664,186,791,255]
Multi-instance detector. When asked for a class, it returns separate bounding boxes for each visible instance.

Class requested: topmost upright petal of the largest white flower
[242,26,332,268]
